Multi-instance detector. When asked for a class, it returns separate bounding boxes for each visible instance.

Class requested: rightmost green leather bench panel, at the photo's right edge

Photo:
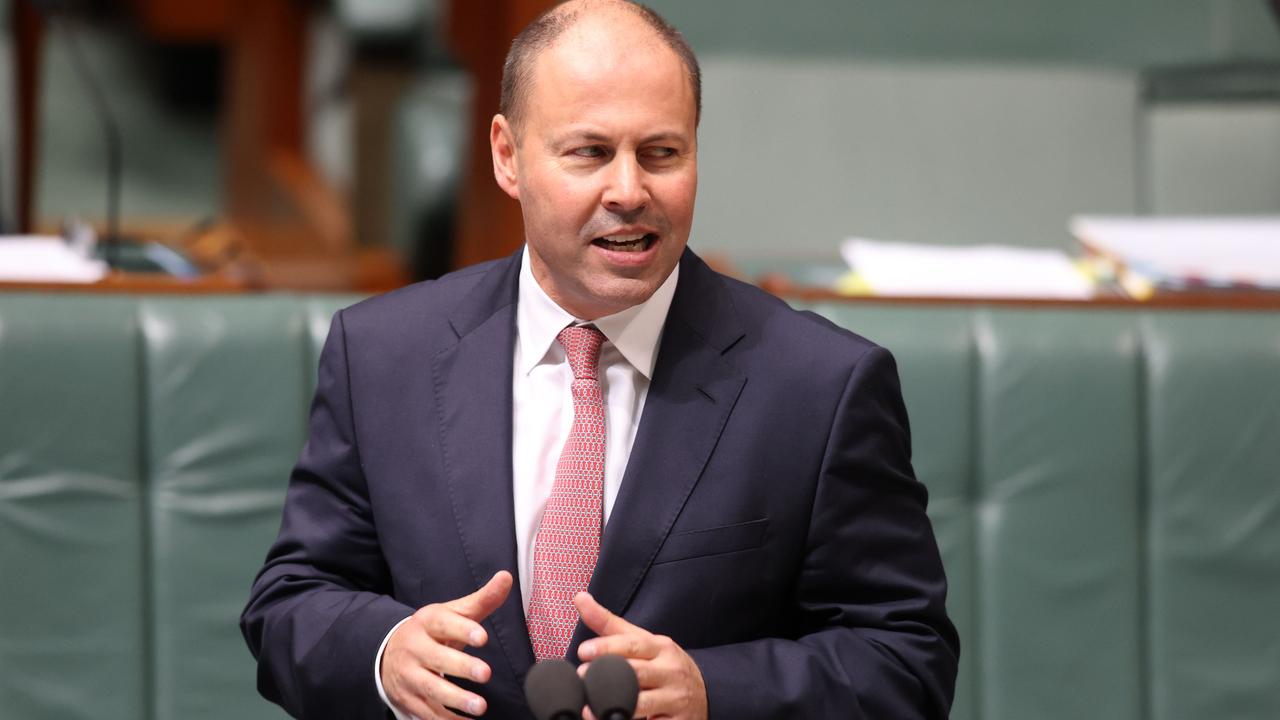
[1143,314,1280,720]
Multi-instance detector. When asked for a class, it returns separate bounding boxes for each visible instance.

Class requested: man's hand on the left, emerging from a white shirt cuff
[381,570,512,720]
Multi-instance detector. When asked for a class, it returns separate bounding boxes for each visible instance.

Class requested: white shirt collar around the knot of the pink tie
[516,245,680,379]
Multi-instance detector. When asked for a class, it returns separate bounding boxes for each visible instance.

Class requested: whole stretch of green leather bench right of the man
[814,304,1280,720]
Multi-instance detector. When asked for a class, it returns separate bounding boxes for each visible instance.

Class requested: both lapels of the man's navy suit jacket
[431,250,746,661]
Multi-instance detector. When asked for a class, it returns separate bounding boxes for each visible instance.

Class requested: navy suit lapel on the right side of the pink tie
[570,250,746,657]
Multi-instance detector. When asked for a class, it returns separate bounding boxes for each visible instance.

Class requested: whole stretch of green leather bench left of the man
[0,295,356,720]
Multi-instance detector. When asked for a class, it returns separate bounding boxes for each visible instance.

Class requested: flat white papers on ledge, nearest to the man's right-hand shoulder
[840,237,1093,300]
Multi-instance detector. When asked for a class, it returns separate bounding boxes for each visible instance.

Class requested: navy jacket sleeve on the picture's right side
[690,347,960,720]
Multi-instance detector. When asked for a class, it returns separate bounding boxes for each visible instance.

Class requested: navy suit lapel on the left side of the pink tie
[431,249,534,678]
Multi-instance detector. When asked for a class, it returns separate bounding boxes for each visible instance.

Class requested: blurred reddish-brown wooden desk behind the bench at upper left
[10,0,408,292]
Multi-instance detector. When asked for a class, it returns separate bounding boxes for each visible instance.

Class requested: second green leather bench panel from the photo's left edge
[138,296,310,719]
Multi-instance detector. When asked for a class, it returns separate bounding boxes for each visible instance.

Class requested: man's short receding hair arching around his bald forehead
[498,0,703,135]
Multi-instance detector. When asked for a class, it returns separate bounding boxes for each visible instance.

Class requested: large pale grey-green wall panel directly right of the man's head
[691,56,1138,257]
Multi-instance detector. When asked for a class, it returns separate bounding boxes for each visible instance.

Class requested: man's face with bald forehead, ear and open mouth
[490,15,698,320]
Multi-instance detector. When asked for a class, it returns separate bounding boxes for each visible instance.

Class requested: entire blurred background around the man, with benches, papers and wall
[0,0,1280,720]
